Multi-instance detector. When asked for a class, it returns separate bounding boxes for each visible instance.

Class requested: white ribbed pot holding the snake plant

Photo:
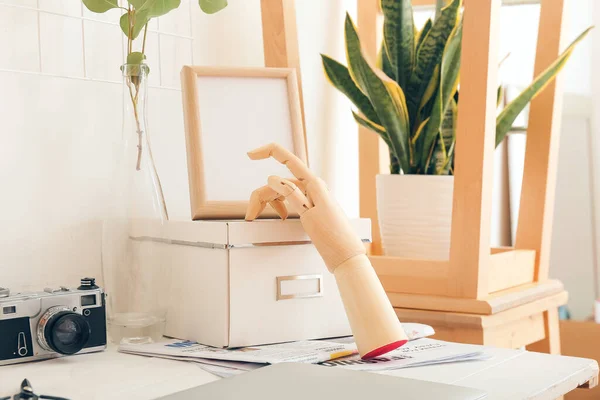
[377,175,454,260]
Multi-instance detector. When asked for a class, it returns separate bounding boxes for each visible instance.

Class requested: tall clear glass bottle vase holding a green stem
[102,64,170,343]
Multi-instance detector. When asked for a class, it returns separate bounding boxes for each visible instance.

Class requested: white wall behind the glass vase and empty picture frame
[0,0,358,290]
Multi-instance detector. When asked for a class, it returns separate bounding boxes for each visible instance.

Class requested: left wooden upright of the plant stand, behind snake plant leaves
[356,0,383,254]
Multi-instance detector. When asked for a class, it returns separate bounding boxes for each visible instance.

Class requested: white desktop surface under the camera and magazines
[0,347,598,400]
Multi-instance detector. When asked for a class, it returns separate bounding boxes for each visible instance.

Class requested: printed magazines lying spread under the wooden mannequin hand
[119,324,489,378]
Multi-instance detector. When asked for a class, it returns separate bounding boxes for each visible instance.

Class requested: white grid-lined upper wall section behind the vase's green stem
[0,0,196,86]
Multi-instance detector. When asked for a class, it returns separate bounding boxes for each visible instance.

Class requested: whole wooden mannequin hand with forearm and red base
[246,143,408,358]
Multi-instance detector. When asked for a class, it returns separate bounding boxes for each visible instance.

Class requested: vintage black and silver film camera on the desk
[0,278,106,365]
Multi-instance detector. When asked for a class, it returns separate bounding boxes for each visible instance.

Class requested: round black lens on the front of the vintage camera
[38,307,90,354]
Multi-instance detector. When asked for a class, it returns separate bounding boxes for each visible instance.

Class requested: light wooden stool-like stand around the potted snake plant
[358,0,567,352]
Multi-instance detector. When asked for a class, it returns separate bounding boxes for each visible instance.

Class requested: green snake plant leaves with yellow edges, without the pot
[321,0,591,175]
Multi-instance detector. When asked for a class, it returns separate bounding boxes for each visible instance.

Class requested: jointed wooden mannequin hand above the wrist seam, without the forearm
[246,143,365,273]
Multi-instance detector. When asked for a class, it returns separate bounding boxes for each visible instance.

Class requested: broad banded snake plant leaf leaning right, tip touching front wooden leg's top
[406,0,462,115]
